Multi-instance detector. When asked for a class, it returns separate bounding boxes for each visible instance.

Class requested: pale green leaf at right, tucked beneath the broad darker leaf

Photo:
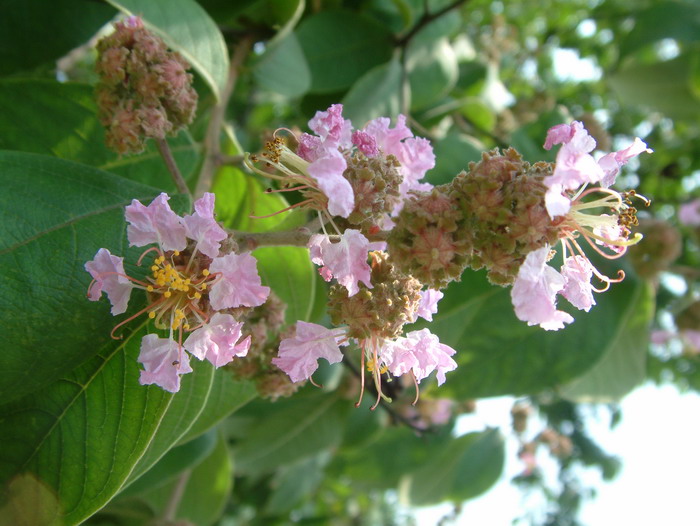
[559,284,654,403]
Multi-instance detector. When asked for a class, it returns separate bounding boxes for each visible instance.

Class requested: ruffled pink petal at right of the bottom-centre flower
[382,329,457,385]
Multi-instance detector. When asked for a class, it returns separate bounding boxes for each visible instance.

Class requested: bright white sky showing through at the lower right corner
[416,385,700,526]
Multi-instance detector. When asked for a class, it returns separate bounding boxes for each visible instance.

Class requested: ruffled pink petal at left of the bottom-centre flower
[272,321,347,382]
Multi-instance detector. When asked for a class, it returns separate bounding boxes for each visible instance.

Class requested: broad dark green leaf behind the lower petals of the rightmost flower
[429,265,642,399]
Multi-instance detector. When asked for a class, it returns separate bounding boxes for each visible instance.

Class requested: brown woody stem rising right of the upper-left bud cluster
[195,37,253,197]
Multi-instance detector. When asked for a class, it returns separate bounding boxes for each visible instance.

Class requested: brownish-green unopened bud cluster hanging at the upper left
[96,16,197,154]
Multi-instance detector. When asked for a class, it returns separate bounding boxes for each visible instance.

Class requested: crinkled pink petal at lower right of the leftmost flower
[183,312,250,367]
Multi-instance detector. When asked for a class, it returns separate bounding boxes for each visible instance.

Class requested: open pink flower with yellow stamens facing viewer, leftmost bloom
[85,193,270,392]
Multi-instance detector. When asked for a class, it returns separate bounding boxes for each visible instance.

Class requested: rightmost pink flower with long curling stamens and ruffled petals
[511,122,652,330]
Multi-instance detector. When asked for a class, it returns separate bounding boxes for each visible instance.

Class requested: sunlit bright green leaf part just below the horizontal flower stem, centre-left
[253,247,317,323]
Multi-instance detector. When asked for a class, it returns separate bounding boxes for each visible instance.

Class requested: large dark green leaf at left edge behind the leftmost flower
[0,152,175,402]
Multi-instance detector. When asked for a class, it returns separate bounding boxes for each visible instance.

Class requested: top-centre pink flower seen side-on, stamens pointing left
[245,104,435,224]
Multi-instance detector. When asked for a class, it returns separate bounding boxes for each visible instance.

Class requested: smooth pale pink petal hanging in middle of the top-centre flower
[308,149,355,217]
